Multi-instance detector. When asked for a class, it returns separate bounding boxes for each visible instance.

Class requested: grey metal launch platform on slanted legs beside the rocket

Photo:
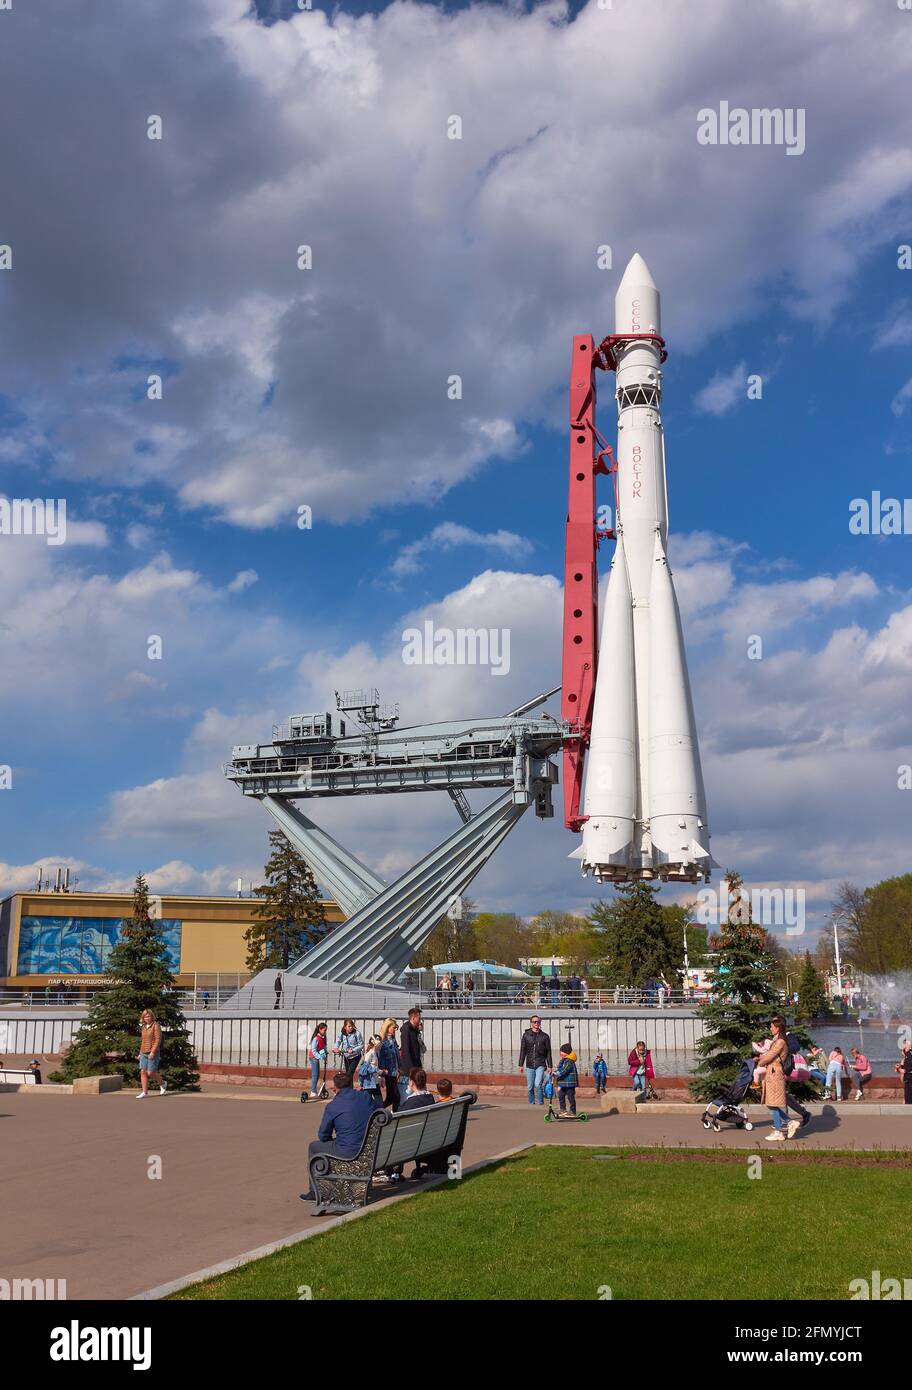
[225,689,569,1009]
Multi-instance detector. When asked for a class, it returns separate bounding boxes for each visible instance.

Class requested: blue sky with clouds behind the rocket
[0,0,912,950]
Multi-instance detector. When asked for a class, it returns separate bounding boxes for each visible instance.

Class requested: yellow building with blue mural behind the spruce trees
[0,891,343,991]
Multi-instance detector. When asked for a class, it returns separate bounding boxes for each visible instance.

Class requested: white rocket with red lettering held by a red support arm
[571,256,712,883]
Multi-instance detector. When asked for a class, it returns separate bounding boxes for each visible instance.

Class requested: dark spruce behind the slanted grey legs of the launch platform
[245,830,327,972]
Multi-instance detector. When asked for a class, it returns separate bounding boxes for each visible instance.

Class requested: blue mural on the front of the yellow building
[17,917,182,974]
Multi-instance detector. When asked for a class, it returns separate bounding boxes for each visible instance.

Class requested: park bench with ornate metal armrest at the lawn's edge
[310,1091,477,1215]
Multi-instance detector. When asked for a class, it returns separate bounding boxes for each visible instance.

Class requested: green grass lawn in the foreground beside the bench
[175,1147,912,1300]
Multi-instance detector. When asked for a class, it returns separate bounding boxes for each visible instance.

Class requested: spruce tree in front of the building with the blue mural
[50,874,199,1090]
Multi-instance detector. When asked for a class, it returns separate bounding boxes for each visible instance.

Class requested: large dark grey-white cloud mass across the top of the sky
[0,0,912,528]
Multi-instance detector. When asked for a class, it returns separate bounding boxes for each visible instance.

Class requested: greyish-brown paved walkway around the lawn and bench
[0,1088,912,1300]
